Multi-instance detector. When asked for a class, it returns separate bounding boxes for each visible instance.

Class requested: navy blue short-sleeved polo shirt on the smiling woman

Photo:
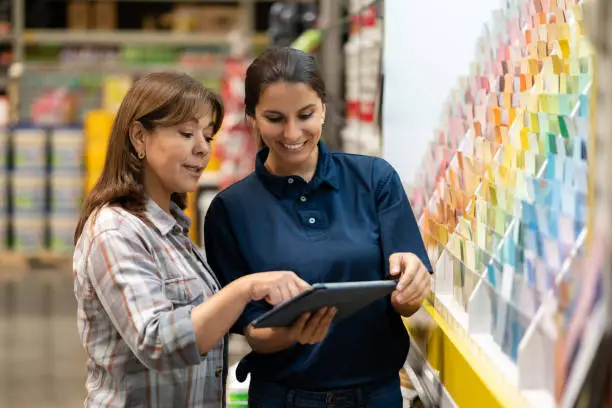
[204,143,431,390]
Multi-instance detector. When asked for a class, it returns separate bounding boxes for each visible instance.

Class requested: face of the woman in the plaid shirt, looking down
[130,103,214,209]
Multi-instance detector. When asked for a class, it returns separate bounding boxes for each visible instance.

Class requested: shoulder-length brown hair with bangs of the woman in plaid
[74,72,224,244]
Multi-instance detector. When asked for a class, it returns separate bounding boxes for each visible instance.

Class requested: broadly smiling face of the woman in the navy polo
[253,81,325,180]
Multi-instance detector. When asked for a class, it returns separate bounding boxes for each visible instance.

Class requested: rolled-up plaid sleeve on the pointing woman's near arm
[86,229,204,371]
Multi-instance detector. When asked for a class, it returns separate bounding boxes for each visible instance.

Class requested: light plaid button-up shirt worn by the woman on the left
[74,200,227,408]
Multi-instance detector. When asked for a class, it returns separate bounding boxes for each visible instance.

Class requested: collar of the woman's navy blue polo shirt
[255,141,338,197]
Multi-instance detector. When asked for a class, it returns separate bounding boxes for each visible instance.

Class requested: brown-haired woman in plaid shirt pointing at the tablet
[74,73,338,408]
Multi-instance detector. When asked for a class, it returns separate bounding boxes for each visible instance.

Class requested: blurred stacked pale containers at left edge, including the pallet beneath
[0,125,84,273]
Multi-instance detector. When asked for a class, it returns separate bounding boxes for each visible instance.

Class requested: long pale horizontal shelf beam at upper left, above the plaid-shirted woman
[24,30,229,46]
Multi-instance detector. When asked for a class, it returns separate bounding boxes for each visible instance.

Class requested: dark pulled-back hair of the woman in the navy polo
[244,47,327,147]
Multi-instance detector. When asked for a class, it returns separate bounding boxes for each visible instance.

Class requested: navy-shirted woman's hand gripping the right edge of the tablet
[389,253,431,317]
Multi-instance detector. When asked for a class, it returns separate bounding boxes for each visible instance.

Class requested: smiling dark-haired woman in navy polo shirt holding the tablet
[204,48,431,408]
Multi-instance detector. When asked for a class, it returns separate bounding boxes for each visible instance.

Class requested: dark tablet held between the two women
[251,281,397,329]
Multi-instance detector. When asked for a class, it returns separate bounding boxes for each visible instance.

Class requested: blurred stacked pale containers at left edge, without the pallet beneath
[5,126,84,253]
